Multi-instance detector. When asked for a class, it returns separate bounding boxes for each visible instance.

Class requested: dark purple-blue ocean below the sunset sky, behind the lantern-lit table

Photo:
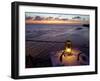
[25,24,89,68]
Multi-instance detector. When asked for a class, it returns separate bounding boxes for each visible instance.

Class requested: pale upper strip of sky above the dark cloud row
[25,12,89,20]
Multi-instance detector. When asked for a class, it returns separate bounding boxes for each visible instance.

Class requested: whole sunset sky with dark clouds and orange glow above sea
[25,12,89,24]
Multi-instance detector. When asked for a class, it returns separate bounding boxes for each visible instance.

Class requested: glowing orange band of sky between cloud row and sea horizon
[25,20,89,25]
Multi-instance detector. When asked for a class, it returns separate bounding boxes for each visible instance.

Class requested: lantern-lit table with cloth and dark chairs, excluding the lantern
[51,49,88,66]
